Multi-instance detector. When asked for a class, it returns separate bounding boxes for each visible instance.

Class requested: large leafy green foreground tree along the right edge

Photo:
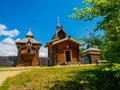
[71,0,120,63]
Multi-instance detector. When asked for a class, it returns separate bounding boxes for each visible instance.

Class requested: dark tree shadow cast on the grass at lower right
[49,66,120,90]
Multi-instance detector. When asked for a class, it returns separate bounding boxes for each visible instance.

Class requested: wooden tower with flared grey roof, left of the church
[16,30,41,66]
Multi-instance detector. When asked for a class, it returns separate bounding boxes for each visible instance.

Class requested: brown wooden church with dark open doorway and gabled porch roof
[46,23,81,65]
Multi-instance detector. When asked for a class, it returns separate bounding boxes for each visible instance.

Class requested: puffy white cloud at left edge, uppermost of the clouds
[0,24,19,37]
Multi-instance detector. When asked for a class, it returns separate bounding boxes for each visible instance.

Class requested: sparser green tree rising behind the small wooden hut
[77,30,106,59]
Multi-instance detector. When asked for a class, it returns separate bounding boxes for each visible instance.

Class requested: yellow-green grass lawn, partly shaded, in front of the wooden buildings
[0,65,118,90]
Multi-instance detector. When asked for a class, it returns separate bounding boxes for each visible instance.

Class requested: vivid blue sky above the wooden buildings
[0,0,101,55]
